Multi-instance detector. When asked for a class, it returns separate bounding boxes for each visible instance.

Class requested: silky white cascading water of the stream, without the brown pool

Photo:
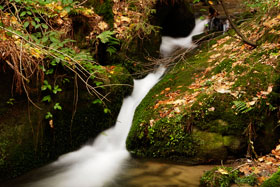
[28,16,208,187]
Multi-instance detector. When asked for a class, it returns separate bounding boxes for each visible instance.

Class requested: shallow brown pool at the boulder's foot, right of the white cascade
[106,160,215,187]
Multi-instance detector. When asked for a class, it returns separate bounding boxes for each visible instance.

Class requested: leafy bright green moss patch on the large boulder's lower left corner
[127,119,197,160]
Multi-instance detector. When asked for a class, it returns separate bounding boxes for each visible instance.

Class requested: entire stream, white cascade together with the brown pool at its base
[2,17,214,187]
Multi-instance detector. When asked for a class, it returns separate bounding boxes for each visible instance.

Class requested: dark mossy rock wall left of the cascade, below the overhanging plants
[0,66,133,180]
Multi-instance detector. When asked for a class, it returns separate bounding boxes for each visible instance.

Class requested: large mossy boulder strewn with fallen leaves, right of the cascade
[127,15,280,163]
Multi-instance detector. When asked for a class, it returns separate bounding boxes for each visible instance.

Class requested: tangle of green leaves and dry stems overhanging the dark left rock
[0,0,119,119]
